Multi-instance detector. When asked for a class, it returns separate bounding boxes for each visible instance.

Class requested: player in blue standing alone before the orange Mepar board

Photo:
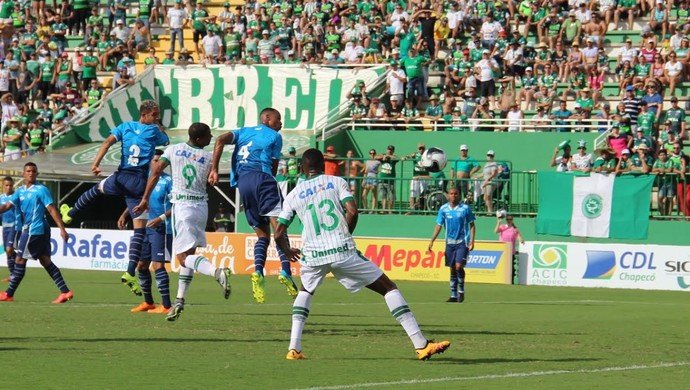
[429,187,475,303]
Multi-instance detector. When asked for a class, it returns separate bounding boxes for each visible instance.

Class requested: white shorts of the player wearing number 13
[300,252,383,293]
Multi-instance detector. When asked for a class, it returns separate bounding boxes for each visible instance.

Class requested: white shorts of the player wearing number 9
[172,202,208,255]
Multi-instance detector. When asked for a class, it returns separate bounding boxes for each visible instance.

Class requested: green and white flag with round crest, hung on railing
[537,172,654,239]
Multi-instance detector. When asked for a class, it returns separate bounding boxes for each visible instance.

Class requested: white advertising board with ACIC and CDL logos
[520,242,690,291]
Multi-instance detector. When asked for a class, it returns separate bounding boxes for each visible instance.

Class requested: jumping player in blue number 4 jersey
[209,108,297,303]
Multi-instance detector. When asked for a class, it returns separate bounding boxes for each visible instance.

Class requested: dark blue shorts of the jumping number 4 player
[237,171,283,228]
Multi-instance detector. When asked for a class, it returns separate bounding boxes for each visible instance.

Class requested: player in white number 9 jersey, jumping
[135,122,230,321]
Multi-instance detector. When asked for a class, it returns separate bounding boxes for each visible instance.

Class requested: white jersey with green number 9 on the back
[161,143,211,203]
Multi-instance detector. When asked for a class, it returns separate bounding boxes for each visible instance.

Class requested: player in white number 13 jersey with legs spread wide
[274,149,450,360]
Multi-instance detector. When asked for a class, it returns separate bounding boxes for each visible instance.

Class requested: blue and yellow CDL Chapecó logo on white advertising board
[582,250,657,283]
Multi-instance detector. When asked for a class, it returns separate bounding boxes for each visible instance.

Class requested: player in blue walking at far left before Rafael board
[0,162,74,303]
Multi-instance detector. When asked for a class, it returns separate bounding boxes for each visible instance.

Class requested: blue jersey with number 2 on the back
[110,122,169,174]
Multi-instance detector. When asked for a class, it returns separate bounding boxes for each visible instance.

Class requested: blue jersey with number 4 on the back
[230,125,283,187]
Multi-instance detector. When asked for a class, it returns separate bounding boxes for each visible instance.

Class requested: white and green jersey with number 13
[278,175,357,266]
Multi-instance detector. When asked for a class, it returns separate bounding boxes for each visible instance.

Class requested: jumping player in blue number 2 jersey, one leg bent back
[60,100,169,295]
